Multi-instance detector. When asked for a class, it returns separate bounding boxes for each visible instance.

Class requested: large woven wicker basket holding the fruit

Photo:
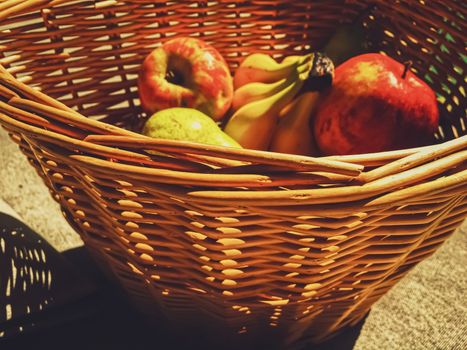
[0,0,467,346]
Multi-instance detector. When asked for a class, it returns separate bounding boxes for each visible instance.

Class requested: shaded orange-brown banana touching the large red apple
[269,91,320,156]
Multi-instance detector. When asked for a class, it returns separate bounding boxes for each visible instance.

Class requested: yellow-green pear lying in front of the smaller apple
[143,107,241,148]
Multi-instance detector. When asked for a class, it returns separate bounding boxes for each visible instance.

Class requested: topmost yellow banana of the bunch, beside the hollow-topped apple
[233,53,313,89]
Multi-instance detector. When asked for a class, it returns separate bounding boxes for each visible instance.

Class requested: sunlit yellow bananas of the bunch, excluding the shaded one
[224,53,314,150]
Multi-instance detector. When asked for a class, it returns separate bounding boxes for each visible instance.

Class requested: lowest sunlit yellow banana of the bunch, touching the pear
[224,73,303,150]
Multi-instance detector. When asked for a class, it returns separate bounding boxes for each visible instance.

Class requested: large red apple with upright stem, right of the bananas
[314,53,439,155]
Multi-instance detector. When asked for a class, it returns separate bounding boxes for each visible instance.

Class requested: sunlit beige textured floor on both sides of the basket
[0,126,467,350]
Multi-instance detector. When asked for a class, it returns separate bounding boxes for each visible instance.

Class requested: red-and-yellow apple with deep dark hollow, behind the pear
[138,37,233,120]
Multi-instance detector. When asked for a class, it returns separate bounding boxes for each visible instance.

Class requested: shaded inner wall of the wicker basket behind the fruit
[0,0,467,140]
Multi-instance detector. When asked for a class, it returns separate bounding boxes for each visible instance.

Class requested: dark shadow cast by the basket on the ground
[0,214,364,350]
